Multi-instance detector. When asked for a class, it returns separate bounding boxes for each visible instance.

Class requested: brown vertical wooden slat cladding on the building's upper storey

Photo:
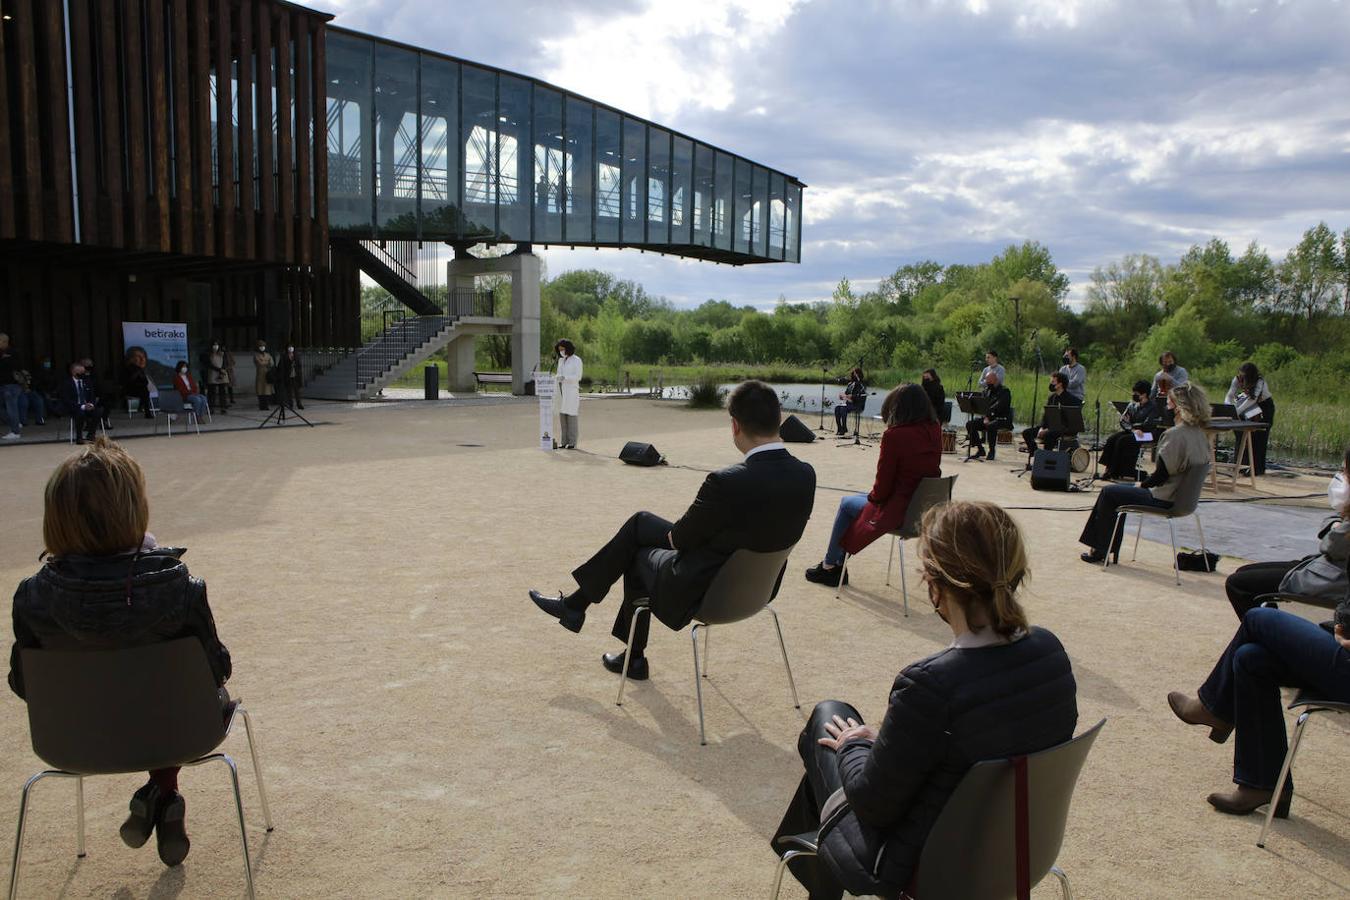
[0,0,328,267]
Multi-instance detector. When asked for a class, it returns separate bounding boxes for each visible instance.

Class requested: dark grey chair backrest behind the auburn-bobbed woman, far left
[22,637,225,775]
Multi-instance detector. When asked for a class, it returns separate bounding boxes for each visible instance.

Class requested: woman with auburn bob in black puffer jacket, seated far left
[9,437,231,866]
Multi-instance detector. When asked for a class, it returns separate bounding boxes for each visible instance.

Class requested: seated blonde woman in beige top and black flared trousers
[1079,383,1210,563]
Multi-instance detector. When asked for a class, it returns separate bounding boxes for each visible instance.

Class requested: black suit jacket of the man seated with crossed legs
[652,449,815,630]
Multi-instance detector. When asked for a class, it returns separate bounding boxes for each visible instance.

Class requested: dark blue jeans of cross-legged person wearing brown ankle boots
[1200,607,1350,791]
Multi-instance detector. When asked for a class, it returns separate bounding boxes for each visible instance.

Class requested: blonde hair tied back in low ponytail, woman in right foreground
[919,501,1031,637]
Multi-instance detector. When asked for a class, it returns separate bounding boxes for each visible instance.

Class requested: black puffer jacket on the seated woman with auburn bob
[9,548,231,698]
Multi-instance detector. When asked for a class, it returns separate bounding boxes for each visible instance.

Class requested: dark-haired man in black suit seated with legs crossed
[529,381,815,680]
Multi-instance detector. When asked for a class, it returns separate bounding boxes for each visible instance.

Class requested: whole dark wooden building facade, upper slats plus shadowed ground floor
[0,0,359,366]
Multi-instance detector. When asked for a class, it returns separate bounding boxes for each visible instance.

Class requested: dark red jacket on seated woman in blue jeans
[842,422,942,553]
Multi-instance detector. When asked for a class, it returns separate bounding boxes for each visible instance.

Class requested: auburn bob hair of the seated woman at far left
[42,436,150,556]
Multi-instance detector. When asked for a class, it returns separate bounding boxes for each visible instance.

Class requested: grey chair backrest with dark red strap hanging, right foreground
[915,719,1106,900]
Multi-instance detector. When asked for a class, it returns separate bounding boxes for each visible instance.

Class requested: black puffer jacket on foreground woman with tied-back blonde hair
[822,627,1079,896]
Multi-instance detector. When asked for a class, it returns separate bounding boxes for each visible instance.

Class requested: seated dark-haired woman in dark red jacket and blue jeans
[806,385,942,587]
